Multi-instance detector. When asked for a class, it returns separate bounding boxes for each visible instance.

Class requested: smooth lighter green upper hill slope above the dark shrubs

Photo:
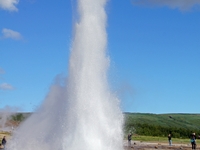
[124,113,200,130]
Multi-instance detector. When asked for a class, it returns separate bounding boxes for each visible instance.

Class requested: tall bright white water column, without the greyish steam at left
[63,0,122,150]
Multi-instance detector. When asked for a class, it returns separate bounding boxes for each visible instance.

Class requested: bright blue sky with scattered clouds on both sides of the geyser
[0,0,200,113]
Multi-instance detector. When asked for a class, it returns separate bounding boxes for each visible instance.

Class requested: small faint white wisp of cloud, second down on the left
[2,28,22,40]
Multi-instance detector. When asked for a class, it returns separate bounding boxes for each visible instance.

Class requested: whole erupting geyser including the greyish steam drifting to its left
[8,0,123,150]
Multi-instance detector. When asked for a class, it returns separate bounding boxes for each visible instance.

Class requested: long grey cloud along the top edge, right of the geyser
[132,0,200,11]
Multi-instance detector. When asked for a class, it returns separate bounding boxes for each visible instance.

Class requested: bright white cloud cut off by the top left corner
[0,0,19,11]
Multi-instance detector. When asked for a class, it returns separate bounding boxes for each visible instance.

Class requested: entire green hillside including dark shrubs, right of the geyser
[124,113,200,138]
